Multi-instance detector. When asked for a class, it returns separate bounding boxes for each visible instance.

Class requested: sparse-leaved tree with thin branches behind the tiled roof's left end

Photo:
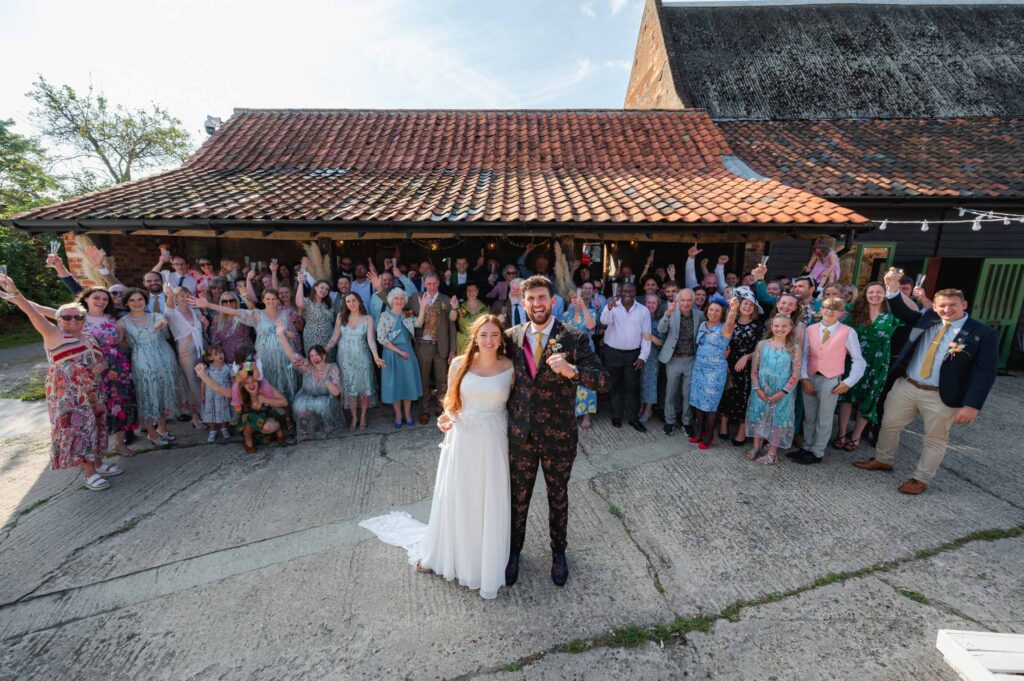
[28,76,191,185]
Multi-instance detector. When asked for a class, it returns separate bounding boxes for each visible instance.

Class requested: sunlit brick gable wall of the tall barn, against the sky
[626,0,685,109]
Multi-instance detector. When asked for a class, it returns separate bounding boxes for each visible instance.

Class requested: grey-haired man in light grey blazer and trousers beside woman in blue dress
[657,289,705,437]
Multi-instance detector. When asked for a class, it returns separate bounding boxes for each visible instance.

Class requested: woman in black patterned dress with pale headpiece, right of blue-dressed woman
[719,286,765,446]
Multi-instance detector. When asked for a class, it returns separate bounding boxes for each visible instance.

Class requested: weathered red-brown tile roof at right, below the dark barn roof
[718,117,1024,199]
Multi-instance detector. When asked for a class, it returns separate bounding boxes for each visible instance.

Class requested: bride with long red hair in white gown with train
[359,314,515,598]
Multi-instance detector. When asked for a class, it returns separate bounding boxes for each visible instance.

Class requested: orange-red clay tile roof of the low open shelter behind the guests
[15,110,865,226]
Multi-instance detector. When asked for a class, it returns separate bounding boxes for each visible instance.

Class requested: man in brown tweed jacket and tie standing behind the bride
[411,271,456,424]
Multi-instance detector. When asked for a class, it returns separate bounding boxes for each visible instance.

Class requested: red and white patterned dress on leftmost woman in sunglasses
[46,334,106,470]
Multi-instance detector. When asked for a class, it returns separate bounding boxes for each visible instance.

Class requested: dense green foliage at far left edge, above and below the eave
[0,121,70,313]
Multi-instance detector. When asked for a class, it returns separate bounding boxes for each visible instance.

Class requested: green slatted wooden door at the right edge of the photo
[969,258,1024,369]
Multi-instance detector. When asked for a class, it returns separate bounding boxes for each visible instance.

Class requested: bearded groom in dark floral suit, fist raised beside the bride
[505,275,608,587]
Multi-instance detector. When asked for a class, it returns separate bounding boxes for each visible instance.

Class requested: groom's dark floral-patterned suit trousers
[509,435,575,553]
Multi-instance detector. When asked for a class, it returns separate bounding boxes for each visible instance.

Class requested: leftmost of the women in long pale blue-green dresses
[118,289,195,446]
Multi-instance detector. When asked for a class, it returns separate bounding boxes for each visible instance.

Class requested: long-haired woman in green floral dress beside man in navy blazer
[833,282,902,452]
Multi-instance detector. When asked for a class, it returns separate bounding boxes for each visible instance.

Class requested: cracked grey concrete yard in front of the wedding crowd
[0,342,1024,681]
